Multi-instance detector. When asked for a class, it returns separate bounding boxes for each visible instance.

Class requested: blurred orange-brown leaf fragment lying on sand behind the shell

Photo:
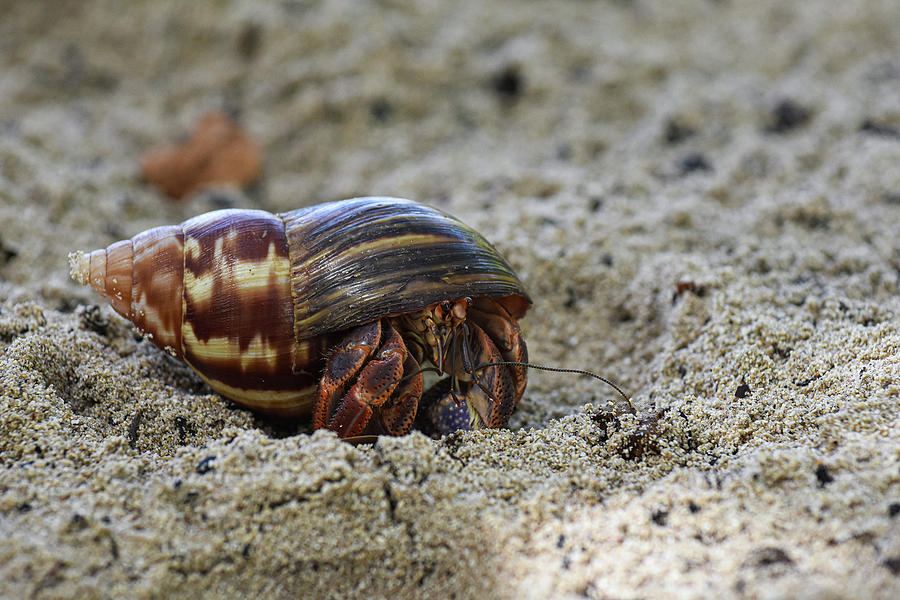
[141,111,262,199]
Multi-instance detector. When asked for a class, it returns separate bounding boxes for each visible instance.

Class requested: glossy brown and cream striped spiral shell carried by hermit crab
[70,198,531,416]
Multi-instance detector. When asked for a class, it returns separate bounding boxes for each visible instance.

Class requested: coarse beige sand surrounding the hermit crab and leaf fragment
[0,0,900,599]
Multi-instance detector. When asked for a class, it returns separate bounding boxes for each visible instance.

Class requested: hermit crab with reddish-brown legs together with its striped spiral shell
[69,198,531,437]
